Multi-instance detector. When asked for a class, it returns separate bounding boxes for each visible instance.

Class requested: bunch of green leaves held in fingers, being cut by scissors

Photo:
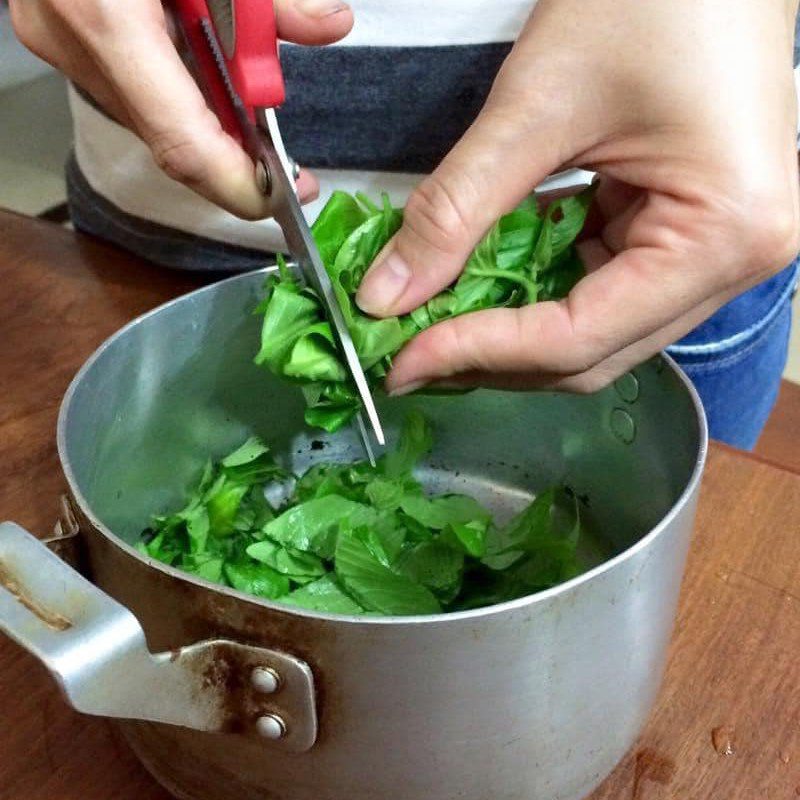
[255,190,591,431]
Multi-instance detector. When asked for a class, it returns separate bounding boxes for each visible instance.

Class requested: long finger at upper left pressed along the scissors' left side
[61,2,269,219]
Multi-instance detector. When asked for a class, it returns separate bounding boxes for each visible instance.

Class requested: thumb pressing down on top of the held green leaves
[356,79,567,317]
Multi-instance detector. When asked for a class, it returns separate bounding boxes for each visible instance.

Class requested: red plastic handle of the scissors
[170,0,285,141]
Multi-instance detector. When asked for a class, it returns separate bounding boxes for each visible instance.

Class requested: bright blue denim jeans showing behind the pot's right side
[667,260,800,450]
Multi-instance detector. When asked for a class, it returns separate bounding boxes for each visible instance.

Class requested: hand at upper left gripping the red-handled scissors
[10,0,353,219]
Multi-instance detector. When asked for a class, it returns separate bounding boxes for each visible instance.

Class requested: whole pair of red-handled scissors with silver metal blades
[170,0,385,465]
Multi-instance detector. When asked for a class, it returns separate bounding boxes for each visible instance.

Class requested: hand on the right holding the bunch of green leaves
[357,0,800,394]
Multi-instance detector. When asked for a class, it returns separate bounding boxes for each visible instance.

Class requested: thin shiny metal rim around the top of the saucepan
[56,267,708,627]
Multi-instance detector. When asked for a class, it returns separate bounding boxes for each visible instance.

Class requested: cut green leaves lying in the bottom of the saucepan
[139,413,581,615]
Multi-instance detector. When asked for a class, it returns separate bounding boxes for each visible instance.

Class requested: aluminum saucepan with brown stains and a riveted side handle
[0,273,707,800]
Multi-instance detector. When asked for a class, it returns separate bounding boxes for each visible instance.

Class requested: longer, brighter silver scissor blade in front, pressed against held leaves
[256,109,386,445]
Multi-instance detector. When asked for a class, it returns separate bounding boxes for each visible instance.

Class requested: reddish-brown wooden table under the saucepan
[0,212,800,800]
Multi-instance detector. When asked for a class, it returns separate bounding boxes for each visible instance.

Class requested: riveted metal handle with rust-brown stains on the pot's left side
[0,522,317,752]
